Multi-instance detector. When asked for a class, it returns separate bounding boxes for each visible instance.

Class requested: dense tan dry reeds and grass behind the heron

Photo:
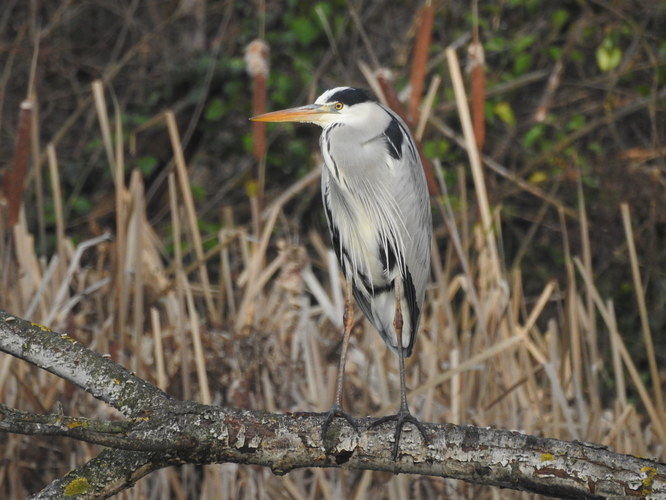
[0,72,666,500]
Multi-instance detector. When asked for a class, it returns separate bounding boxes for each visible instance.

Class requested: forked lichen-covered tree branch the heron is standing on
[0,311,666,498]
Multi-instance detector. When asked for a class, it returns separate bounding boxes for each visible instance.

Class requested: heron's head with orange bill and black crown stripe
[250,87,381,127]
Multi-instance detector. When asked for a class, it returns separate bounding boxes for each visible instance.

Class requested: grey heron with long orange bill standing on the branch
[251,87,432,459]
